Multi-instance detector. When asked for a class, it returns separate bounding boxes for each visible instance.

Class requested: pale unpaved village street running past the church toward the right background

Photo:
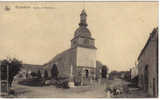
[9,79,147,98]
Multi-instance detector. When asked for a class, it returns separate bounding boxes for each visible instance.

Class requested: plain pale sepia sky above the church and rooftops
[0,2,158,71]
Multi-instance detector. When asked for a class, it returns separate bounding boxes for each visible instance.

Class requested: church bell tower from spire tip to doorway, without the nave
[71,10,97,83]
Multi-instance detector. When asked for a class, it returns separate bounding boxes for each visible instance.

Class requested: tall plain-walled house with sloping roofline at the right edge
[138,28,158,97]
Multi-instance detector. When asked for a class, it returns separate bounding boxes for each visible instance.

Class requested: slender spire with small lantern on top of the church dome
[79,9,88,27]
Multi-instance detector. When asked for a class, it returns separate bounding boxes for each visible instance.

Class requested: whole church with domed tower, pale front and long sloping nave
[44,10,102,85]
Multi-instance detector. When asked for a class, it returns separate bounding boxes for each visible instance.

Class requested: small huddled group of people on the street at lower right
[106,88,122,98]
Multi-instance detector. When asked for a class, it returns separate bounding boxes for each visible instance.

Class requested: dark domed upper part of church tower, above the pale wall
[71,10,96,49]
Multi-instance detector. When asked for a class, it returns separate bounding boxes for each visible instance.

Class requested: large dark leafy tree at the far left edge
[1,58,22,87]
